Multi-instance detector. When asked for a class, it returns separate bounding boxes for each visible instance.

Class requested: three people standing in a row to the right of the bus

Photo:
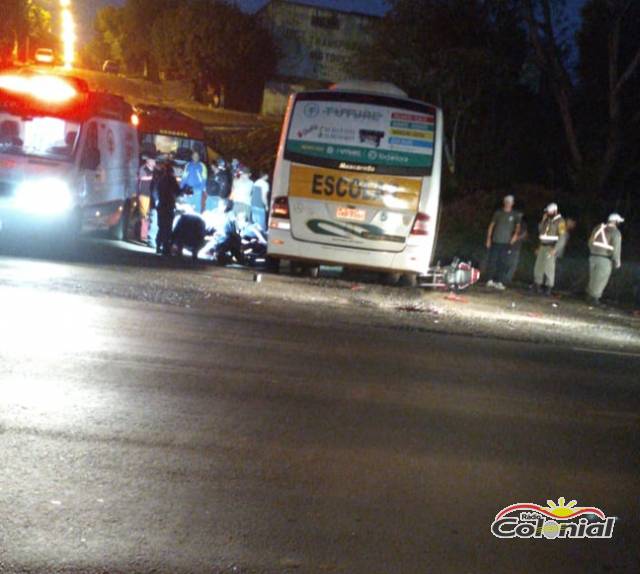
[486,195,624,305]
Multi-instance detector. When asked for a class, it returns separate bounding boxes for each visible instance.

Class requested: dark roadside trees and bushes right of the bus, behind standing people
[355,0,640,257]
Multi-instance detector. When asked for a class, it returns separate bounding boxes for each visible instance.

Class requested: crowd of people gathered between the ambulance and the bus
[139,151,270,262]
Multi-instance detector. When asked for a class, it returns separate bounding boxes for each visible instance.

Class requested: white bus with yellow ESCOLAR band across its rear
[268,82,443,284]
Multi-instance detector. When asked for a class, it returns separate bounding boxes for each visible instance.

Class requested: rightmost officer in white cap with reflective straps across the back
[587,213,624,305]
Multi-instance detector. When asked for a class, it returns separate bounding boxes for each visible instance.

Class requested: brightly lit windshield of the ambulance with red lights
[0,113,80,160]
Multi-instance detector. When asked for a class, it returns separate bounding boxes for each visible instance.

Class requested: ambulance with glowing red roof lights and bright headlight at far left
[0,69,139,239]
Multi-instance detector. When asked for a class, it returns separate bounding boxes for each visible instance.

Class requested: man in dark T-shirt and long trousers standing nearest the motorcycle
[487,195,522,291]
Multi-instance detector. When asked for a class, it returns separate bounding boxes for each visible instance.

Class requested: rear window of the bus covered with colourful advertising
[285,93,436,176]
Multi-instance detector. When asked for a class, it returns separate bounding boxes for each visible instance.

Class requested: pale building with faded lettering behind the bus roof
[259,0,377,114]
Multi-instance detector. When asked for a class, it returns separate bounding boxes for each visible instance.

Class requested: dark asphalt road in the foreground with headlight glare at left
[0,243,640,574]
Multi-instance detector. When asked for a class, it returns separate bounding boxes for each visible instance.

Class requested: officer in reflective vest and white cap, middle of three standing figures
[533,203,567,295]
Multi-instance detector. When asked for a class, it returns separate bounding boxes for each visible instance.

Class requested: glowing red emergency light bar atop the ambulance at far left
[0,74,87,105]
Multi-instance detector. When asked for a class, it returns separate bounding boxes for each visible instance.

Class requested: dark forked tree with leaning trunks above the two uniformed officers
[523,0,640,199]
